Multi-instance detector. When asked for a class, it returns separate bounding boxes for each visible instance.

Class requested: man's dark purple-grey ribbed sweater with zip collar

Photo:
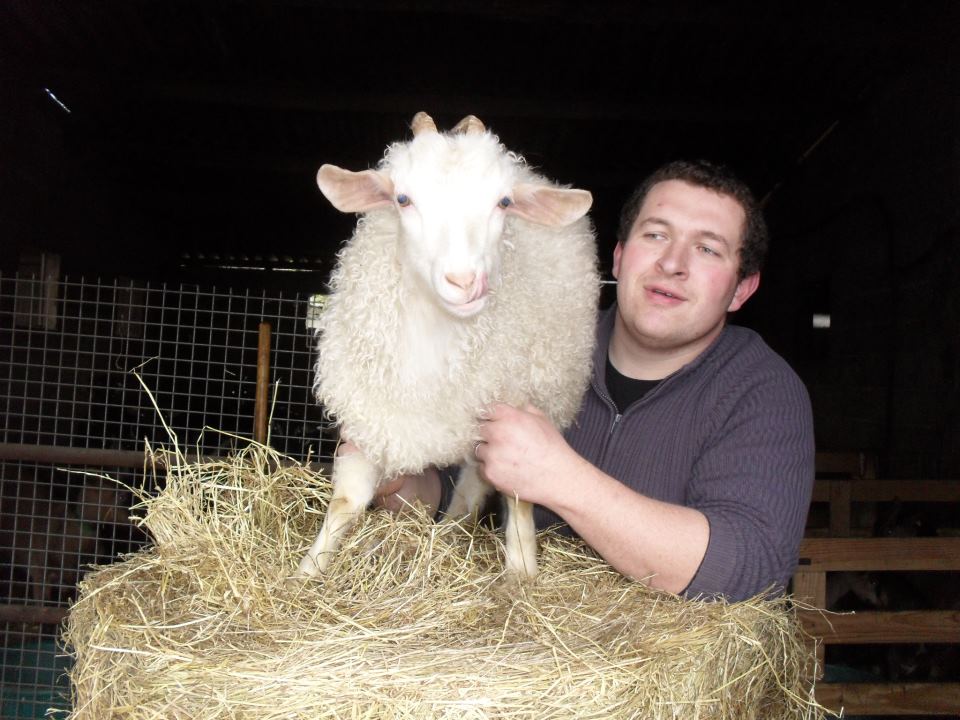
[535,306,814,600]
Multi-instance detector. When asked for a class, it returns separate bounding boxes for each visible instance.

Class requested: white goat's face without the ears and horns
[390,133,515,317]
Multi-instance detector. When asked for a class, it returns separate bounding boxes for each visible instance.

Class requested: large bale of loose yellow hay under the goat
[64,445,822,720]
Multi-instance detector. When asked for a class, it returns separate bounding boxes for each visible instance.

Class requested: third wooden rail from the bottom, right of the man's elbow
[797,537,960,573]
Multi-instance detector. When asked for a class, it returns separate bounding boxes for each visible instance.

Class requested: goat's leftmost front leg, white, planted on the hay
[298,452,380,577]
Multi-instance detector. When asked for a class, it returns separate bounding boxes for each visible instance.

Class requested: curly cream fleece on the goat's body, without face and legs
[316,139,599,477]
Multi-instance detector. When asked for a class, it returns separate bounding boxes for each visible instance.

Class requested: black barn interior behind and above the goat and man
[0,0,960,477]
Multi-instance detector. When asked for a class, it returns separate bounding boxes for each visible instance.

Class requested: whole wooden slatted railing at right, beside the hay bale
[793,453,960,716]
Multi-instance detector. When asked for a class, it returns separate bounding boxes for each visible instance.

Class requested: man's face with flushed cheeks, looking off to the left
[613,180,759,355]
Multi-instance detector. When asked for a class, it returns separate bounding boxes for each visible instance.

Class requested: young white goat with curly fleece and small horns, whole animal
[300,113,599,578]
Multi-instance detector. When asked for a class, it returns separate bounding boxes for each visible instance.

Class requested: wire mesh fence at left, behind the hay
[0,275,335,718]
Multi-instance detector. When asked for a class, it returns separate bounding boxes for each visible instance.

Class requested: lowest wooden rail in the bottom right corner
[814,683,960,716]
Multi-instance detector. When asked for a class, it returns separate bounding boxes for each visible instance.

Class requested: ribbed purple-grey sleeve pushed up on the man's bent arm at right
[685,342,814,600]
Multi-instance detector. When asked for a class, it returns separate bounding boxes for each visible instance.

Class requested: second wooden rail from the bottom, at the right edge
[799,610,960,645]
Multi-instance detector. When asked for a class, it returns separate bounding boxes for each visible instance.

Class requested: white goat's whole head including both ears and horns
[317,113,592,318]
